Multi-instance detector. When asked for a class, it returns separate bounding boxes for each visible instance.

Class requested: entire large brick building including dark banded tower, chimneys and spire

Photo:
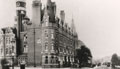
[0,0,78,67]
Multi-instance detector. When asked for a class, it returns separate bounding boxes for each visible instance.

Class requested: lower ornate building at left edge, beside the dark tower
[0,27,17,62]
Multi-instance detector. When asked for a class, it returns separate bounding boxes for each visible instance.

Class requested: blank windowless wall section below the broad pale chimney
[27,28,42,65]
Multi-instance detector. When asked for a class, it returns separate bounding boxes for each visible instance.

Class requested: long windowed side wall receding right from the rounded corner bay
[58,23,75,64]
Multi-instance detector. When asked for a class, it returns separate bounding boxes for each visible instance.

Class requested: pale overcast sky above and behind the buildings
[0,0,120,58]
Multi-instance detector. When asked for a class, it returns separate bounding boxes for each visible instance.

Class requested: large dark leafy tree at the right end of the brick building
[76,45,92,67]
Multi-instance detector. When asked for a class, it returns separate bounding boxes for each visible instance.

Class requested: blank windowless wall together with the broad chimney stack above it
[27,0,42,67]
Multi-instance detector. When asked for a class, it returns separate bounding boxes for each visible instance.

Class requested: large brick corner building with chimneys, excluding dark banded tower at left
[16,1,78,66]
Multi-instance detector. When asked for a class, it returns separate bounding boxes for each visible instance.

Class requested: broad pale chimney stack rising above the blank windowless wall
[32,0,42,27]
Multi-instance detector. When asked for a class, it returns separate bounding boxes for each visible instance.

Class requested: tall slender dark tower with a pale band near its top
[16,0,26,55]
